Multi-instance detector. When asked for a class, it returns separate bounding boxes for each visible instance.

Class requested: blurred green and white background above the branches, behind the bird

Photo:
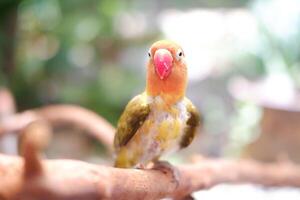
[0,0,300,161]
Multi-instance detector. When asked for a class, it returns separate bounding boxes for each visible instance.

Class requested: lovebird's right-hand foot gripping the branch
[152,161,180,188]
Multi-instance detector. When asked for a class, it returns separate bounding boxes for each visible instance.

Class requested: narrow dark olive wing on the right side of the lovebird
[180,98,203,148]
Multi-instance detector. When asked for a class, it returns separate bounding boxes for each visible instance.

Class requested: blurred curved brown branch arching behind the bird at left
[0,105,115,151]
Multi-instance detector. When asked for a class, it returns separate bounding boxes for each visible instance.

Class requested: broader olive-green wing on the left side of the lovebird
[114,94,150,150]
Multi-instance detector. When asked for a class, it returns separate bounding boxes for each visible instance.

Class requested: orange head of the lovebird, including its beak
[146,40,187,104]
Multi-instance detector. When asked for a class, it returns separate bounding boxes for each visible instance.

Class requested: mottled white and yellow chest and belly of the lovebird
[140,97,189,162]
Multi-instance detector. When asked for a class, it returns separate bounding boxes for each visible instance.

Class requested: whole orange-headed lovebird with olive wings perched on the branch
[114,40,202,168]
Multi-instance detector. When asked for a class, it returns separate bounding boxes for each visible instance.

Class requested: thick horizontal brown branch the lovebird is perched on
[0,155,300,200]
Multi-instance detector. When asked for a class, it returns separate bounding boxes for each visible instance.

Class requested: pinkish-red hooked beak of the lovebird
[153,49,173,80]
